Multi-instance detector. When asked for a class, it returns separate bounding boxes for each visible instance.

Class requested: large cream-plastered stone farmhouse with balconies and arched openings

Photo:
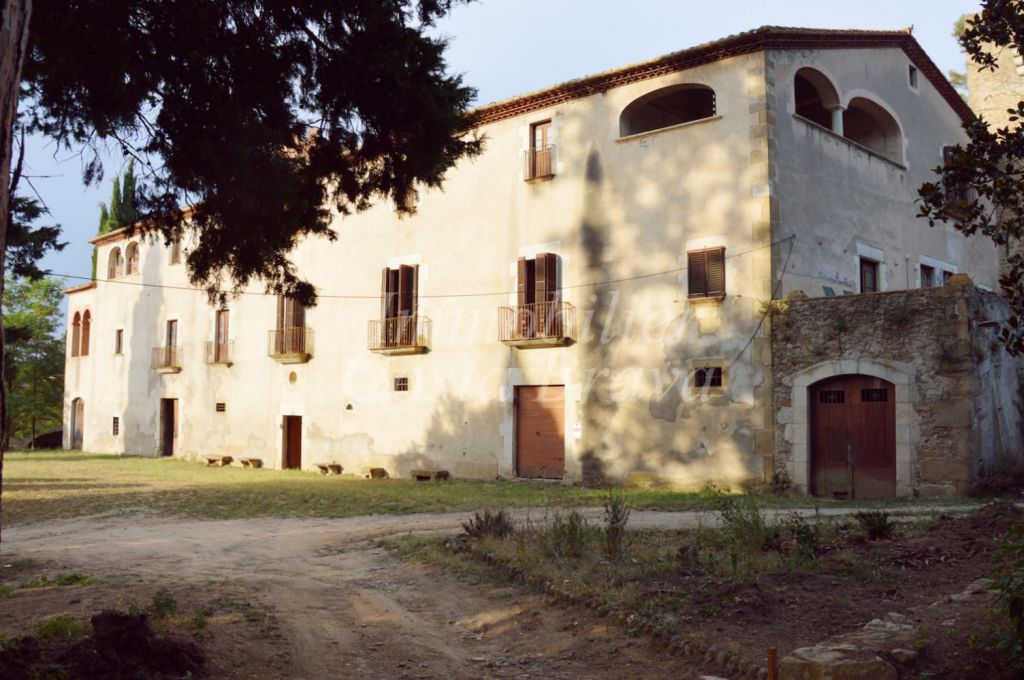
[65,27,1024,498]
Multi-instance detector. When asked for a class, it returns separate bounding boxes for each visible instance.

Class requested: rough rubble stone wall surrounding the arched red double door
[772,275,1024,496]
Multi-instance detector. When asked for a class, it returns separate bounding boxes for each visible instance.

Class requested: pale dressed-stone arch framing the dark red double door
[784,358,918,496]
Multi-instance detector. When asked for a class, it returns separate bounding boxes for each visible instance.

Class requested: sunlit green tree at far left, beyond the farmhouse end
[3,277,65,448]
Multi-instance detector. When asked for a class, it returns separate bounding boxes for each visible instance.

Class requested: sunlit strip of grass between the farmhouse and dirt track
[3,451,974,525]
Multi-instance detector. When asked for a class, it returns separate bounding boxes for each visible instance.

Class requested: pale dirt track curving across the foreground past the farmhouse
[4,508,974,680]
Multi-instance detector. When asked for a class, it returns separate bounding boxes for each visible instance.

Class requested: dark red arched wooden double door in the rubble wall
[808,375,896,499]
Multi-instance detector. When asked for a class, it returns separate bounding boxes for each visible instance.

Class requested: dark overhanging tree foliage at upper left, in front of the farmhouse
[22,0,479,303]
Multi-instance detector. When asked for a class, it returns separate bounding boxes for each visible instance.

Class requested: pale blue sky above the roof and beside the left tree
[26,0,979,284]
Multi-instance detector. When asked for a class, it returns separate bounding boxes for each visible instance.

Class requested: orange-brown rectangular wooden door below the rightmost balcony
[515,385,565,479]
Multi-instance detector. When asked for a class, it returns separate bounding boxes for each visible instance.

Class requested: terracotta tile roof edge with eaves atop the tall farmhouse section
[475,26,974,125]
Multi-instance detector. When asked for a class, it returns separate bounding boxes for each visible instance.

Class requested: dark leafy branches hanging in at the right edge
[919,0,1024,354]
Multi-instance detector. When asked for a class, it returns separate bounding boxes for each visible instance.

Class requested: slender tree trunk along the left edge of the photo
[0,0,32,557]
